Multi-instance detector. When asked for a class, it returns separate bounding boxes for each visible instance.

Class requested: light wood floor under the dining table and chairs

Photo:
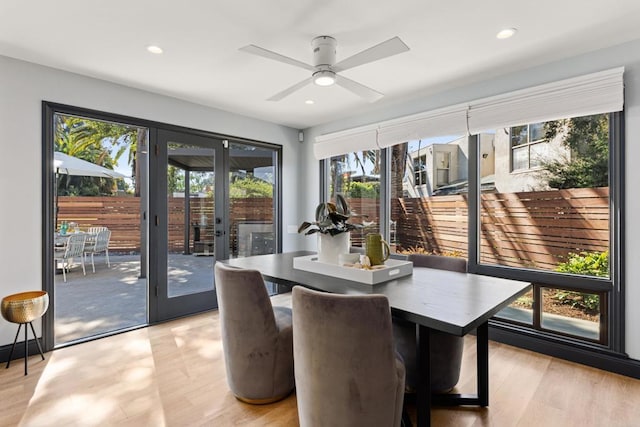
[0,312,640,427]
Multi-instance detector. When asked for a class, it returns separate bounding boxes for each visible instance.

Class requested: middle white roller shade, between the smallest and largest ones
[378,104,468,148]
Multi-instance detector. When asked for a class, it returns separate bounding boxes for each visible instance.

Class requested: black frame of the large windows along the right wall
[319,111,624,364]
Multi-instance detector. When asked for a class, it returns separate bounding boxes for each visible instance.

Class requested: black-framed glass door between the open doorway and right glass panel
[150,129,228,322]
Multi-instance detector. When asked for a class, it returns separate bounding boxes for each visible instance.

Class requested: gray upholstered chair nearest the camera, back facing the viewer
[293,286,405,427]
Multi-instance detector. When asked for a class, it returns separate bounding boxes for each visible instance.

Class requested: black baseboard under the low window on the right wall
[489,322,640,379]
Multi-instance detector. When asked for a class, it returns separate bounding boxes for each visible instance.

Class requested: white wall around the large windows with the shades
[303,40,640,360]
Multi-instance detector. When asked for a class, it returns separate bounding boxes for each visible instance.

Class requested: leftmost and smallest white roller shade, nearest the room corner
[313,125,378,160]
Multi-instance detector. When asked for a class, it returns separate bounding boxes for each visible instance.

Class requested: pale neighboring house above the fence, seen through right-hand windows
[403,123,571,197]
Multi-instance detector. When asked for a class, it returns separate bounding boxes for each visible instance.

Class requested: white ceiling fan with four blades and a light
[240,36,409,102]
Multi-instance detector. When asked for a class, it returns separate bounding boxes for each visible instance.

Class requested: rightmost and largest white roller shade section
[469,67,624,134]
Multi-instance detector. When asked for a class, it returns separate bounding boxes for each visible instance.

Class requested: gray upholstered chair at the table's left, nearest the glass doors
[215,263,294,404]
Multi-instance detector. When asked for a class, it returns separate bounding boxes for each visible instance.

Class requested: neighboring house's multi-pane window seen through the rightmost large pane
[509,123,548,171]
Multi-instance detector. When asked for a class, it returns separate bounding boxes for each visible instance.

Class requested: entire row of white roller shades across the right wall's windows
[313,67,624,159]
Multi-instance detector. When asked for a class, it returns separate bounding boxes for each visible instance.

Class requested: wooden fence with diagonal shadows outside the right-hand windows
[391,187,609,269]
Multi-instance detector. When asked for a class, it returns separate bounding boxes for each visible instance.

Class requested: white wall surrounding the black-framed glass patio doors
[0,56,304,345]
